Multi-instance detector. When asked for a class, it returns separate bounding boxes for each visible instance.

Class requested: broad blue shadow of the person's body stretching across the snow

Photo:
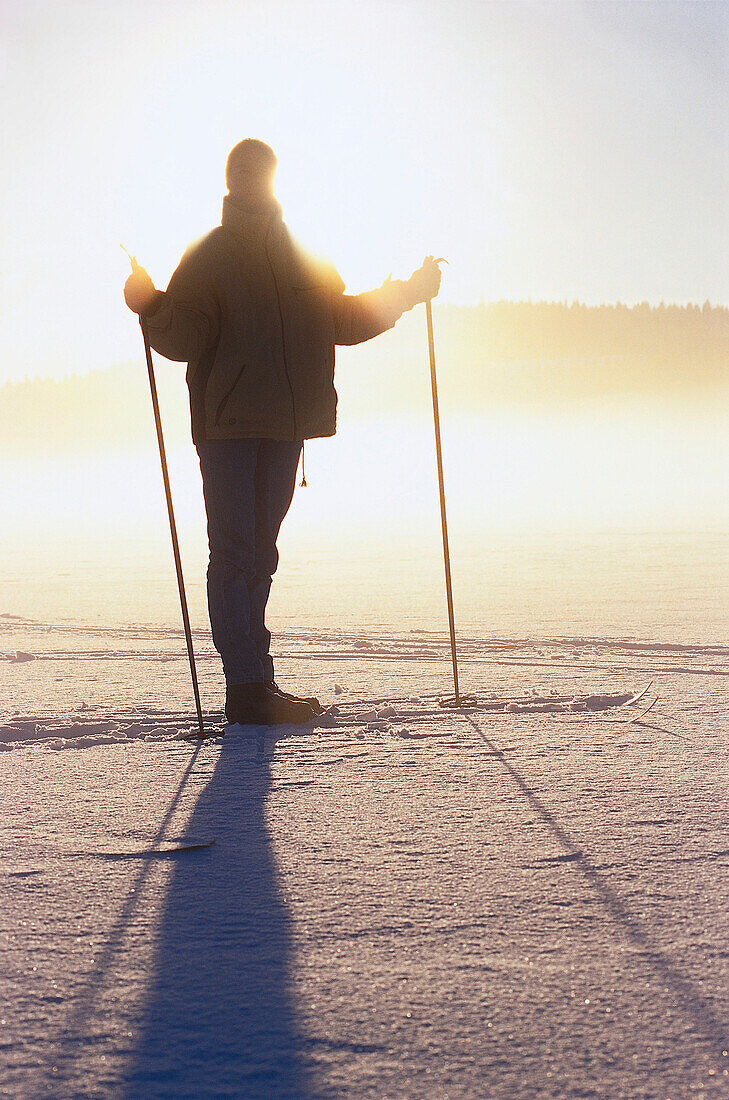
[124,741,313,1100]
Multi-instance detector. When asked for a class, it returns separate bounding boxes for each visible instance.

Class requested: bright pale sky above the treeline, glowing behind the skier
[0,0,729,382]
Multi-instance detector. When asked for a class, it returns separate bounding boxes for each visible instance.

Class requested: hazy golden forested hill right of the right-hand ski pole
[428,301,729,402]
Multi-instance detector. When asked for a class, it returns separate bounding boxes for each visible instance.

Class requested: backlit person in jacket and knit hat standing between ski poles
[124,138,440,725]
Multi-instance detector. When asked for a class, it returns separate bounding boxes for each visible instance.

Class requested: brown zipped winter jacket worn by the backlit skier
[144,195,413,443]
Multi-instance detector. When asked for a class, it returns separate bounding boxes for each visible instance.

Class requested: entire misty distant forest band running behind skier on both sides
[0,301,729,454]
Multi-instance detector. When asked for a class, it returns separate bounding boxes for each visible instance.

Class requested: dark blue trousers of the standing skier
[198,439,301,684]
